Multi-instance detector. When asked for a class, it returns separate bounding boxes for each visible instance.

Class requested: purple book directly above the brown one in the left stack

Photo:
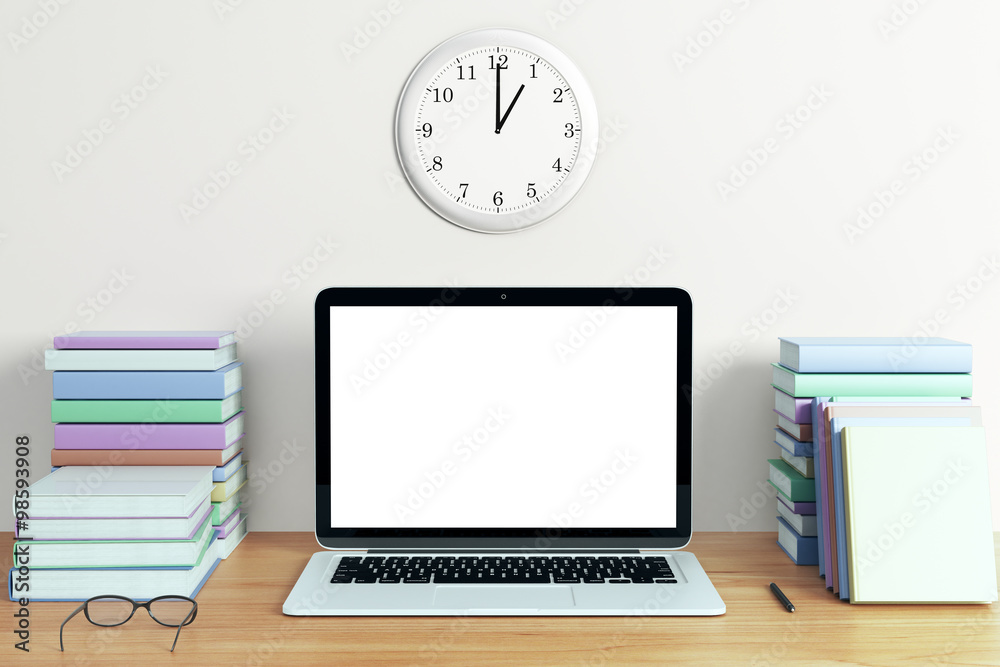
[53,411,244,449]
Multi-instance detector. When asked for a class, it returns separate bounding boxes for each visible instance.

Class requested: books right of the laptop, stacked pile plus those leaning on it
[769,338,996,602]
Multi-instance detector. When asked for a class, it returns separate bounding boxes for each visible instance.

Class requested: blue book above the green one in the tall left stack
[52,361,243,400]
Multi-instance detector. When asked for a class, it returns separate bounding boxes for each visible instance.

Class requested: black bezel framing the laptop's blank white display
[314,286,692,552]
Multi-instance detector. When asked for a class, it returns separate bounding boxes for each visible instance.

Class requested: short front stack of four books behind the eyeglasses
[9,466,221,600]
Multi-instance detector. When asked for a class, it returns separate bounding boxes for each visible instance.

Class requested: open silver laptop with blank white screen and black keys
[282,287,726,616]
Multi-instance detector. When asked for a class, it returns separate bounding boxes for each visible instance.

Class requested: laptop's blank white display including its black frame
[316,288,690,548]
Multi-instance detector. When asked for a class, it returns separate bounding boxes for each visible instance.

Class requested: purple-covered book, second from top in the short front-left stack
[16,496,214,541]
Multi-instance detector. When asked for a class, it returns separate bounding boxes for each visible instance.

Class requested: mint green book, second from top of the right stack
[771,363,972,398]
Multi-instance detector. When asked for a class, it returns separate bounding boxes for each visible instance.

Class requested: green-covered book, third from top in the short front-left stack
[14,516,215,570]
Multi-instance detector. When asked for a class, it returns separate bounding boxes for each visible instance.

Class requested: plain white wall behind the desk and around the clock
[0,0,1000,531]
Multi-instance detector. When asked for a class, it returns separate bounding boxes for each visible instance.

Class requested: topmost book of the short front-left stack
[20,466,213,520]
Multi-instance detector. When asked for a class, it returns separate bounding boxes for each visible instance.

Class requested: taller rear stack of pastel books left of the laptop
[45,331,247,558]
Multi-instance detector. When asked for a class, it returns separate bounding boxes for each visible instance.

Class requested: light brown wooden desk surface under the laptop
[0,533,1000,666]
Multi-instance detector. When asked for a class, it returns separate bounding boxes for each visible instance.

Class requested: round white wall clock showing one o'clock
[396,29,597,233]
